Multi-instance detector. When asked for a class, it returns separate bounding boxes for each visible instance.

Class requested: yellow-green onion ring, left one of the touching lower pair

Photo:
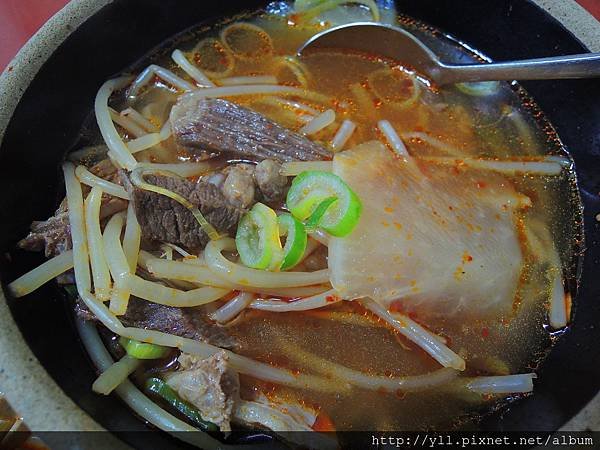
[235,203,283,270]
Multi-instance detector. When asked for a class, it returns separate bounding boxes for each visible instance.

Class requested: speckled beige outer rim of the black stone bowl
[0,0,600,431]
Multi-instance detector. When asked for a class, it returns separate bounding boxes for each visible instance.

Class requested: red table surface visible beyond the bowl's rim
[0,0,600,72]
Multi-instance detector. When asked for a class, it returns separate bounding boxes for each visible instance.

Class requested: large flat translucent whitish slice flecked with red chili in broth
[329,142,530,315]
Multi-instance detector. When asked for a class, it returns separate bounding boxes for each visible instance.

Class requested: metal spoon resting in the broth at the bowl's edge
[298,22,600,85]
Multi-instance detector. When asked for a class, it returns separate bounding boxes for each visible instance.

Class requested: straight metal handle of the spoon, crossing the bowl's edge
[436,53,600,84]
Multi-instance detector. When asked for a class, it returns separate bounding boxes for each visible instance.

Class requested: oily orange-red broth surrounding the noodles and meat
[9,3,582,438]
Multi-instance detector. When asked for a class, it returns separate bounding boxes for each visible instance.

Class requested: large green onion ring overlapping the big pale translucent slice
[286,170,362,237]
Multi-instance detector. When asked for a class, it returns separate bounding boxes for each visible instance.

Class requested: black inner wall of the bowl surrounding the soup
[0,0,600,449]
